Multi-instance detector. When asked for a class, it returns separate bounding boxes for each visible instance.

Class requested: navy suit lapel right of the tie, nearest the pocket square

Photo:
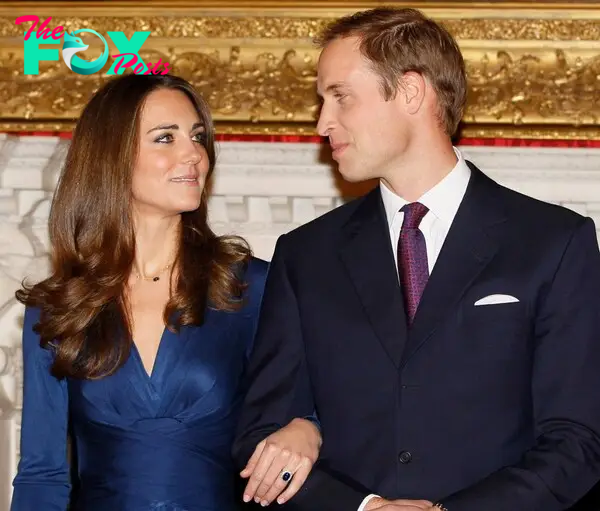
[402,163,506,365]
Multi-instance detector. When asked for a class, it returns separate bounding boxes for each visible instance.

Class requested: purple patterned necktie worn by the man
[398,202,429,325]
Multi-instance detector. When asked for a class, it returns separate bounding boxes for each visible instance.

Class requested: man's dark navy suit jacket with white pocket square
[234,164,600,511]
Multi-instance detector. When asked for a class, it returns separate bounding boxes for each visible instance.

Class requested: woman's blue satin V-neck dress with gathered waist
[11,259,267,511]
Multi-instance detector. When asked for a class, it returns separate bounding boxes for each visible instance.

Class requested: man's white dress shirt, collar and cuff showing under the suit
[358,148,471,511]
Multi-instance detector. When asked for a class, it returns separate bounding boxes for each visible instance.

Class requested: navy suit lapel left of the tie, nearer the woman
[340,187,407,367]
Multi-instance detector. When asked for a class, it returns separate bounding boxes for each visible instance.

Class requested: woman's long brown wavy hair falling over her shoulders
[16,74,251,379]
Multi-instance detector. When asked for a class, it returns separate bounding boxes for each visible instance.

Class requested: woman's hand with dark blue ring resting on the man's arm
[240,419,322,506]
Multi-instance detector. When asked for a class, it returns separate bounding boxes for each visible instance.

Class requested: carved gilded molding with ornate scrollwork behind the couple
[0,0,600,139]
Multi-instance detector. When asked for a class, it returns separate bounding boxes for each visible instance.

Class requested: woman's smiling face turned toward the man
[132,89,210,217]
